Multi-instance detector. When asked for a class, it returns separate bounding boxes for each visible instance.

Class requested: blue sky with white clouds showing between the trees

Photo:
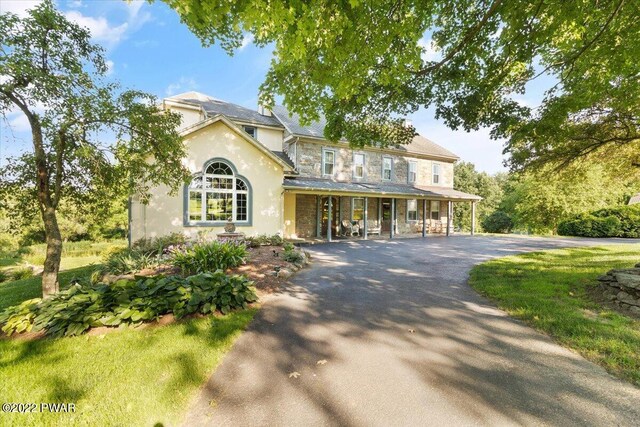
[0,0,548,173]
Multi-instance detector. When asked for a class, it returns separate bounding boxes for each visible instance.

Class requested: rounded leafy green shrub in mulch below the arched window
[171,241,247,274]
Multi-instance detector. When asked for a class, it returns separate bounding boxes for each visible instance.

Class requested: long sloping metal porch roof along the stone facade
[283,177,482,201]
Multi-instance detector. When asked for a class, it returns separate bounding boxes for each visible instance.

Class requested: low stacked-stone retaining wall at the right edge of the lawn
[598,263,640,314]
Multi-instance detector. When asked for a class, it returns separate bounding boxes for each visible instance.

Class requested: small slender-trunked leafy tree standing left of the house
[0,0,187,295]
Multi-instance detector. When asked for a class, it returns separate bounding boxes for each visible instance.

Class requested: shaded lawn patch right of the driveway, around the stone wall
[469,244,640,386]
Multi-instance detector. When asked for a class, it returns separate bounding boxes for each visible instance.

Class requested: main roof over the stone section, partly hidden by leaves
[273,105,460,160]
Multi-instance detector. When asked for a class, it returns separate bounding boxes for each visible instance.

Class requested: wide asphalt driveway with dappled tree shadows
[185,236,640,426]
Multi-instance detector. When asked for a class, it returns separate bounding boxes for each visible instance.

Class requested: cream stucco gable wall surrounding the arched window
[131,122,284,241]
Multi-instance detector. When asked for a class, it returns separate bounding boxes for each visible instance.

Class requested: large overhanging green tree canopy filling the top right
[163,0,640,168]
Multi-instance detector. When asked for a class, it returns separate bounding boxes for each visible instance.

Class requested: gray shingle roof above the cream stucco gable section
[167,92,283,127]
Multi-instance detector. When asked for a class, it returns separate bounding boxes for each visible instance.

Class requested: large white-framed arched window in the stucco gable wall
[188,160,251,223]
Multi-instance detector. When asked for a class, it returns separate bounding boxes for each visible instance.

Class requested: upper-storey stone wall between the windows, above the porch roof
[295,140,453,188]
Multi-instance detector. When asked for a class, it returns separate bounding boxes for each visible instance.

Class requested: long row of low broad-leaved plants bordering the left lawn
[0,270,257,337]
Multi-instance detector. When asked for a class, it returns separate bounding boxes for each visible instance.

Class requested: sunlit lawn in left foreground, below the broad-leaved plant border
[0,309,255,426]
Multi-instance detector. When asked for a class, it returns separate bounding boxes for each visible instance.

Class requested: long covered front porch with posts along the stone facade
[284,178,481,241]
